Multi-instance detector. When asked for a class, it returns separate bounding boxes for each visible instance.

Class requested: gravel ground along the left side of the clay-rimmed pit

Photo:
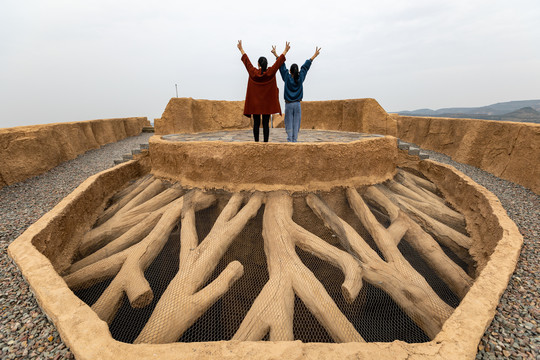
[0,133,153,360]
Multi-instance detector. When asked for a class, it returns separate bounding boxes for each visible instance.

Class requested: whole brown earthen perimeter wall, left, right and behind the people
[0,98,540,194]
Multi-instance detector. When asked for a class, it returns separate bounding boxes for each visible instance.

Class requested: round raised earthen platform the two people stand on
[149,129,397,191]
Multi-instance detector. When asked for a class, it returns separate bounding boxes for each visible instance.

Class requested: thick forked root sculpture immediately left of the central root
[135,193,264,343]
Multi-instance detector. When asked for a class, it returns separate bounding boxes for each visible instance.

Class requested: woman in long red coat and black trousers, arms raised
[238,40,291,142]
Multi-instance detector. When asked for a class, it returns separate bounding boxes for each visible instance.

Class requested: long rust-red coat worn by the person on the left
[242,54,285,117]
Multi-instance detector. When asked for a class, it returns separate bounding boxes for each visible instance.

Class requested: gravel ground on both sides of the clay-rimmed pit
[0,134,540,360]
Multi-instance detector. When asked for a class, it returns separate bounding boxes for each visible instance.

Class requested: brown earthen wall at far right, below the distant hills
[395,115,540,194]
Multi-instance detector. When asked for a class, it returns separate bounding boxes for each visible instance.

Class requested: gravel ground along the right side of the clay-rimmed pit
[425,150,540,360]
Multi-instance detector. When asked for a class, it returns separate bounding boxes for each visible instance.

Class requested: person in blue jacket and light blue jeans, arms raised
[272,46,321,142]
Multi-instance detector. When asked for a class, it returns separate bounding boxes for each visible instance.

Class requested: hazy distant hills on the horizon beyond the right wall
[398,100,540,123]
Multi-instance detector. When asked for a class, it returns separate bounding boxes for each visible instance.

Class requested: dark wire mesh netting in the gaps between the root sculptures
[70,179,467,343]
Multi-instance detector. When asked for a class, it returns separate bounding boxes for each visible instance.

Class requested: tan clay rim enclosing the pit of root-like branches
[8,148,523,359]
